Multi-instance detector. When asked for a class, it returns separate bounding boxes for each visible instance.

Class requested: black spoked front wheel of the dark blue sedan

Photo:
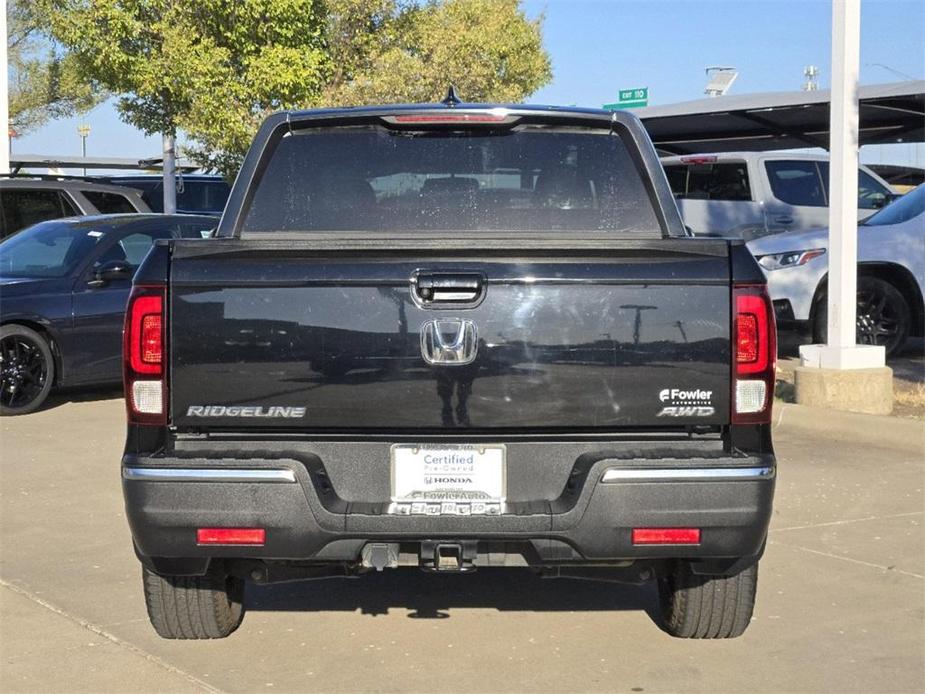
[0,325,55,416]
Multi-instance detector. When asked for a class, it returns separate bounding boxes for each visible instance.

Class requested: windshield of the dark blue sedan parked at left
[0,222,106,278]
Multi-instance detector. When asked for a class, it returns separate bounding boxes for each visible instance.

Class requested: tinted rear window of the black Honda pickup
[242,126,661,237]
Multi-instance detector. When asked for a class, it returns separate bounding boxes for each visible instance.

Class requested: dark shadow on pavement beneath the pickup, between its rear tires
[246,568,659,622]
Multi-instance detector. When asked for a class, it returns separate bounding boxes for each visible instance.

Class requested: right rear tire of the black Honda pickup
[659,561,758,639]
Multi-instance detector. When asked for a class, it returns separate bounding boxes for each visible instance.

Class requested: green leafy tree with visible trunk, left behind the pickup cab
[34,0,326,201]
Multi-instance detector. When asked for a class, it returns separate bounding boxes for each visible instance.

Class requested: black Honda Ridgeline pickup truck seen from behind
[122,99,776,638]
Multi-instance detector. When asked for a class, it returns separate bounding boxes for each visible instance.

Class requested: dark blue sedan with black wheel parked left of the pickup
[0,213,215,415]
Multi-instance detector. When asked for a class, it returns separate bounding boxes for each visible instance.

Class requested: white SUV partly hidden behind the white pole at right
[748,186,925,354]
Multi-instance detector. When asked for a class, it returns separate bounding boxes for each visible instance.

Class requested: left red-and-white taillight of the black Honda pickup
[122,286,167,424]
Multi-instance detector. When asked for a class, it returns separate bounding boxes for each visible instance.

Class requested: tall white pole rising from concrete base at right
[828,0,861,350]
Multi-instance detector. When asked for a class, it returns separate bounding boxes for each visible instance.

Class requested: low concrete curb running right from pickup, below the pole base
[773,402,925,454]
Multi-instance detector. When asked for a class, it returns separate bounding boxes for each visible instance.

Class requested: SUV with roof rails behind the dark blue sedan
[0,176,151,239]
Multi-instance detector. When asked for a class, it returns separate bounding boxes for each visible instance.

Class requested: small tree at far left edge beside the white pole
[7,0,105,135]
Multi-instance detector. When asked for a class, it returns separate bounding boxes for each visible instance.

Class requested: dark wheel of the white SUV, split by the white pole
[813,277,912,356]
